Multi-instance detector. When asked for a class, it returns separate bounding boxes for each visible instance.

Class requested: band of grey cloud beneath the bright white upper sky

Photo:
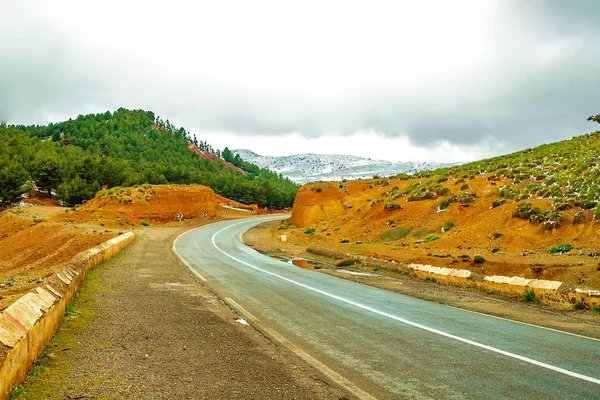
[0,1,600,158]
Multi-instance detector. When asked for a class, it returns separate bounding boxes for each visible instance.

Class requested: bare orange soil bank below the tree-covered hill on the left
[0,185,257,309]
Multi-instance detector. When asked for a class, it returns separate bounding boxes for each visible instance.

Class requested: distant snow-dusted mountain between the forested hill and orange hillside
[231,149,456,184]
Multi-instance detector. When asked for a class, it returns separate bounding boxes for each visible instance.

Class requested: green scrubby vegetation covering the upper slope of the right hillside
[386,127,600,220]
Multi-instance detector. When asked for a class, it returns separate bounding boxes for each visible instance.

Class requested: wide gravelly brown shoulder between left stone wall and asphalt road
[14,227,350,399]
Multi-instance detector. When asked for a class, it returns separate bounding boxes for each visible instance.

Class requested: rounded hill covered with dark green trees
[0,108,298,208]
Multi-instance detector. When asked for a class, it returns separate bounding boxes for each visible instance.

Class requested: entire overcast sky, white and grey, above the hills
[0,0,600,161]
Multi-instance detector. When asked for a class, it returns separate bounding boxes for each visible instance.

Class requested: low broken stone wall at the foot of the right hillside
[358,257,600,310]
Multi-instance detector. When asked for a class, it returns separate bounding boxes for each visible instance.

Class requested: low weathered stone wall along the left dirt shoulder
[0,232,135,399]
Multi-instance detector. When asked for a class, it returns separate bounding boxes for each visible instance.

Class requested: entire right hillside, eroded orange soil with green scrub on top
[278,133,600,288]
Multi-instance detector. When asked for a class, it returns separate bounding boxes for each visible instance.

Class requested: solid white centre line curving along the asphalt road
[211,222,600,385]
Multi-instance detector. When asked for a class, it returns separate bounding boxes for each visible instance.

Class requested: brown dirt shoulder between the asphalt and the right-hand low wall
[243,222,600,339]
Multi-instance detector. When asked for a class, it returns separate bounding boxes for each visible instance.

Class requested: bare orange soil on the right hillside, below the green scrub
[284,175,600,288]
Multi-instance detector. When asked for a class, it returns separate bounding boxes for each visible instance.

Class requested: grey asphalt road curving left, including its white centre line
[174,217,600,399]
